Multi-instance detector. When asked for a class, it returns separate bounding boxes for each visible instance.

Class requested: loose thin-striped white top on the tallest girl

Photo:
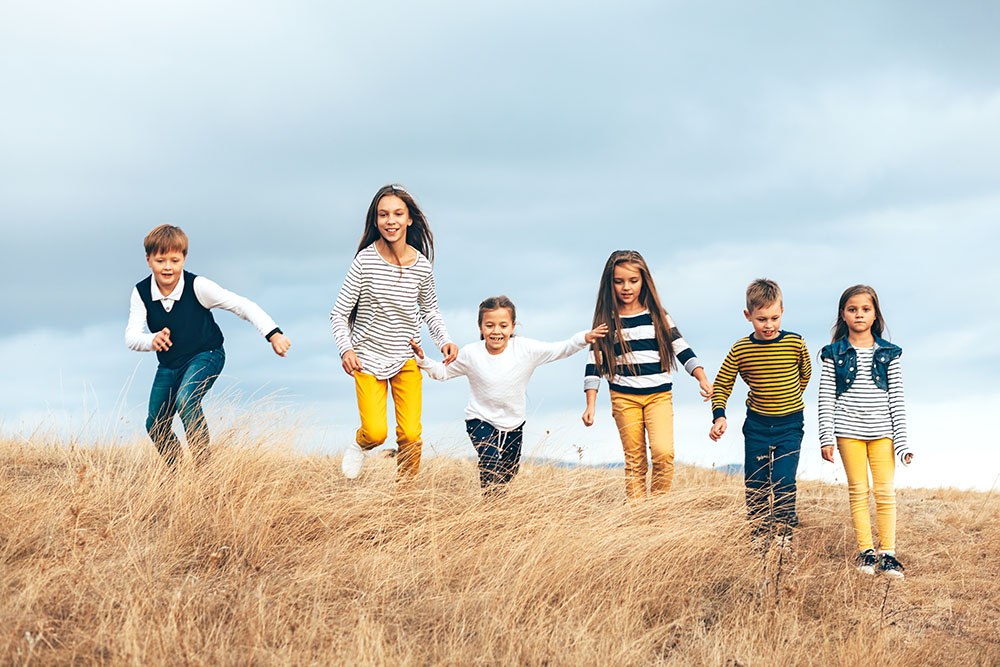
[330,244,451,380]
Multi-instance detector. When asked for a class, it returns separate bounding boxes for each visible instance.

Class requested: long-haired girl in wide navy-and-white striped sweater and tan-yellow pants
[583,250,712,501]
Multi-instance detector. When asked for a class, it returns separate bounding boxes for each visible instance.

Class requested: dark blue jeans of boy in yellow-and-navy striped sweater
[743,411,802,531]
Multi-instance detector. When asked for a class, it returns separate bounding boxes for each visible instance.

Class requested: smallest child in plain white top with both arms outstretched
[411,296,608,495]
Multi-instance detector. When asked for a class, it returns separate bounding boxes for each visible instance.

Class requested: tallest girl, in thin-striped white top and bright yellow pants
[330,185,458,479]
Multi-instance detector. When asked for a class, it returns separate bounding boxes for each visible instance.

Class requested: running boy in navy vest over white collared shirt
[125,225,291,467]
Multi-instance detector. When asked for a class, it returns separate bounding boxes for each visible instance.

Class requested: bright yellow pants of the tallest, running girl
[354,359,421,477]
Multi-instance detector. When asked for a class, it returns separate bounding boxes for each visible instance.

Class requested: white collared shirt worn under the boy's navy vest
[125,274,277,352]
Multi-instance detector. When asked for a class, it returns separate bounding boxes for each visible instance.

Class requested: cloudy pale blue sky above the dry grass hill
[0,0,1000,489]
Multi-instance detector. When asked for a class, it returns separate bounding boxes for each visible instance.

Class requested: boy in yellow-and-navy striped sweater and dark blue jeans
[708,278,812,546]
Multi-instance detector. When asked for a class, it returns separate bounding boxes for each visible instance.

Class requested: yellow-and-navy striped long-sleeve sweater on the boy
[712,331,812,420]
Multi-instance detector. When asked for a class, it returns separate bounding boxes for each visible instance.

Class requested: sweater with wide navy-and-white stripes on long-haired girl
[583,310,701,394]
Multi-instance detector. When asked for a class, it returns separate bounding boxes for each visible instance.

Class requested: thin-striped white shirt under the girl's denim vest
[819,346,909,457]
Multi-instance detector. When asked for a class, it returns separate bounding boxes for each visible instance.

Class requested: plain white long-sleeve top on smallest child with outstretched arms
[417,331,587,431]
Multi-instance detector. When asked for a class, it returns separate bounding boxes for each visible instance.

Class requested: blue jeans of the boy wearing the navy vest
[146,347,226,466]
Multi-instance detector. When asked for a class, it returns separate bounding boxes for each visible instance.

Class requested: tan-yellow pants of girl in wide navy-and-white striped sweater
[611,391,674,500]
